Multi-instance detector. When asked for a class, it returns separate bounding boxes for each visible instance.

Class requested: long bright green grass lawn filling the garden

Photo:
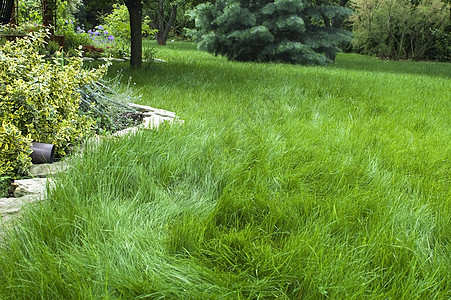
[0,43,451,299]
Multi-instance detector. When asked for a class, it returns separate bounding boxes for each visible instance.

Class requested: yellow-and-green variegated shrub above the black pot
[0,32,107,174]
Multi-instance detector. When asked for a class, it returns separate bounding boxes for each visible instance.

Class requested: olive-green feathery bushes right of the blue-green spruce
[352,0,451,61]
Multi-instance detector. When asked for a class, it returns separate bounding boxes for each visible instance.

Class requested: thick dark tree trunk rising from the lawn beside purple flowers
[125,0,142,69]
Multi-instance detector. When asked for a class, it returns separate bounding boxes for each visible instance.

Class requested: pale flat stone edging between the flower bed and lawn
[0,103,184,231]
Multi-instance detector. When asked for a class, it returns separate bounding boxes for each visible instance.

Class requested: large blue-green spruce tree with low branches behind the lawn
[190,0,351,64]
